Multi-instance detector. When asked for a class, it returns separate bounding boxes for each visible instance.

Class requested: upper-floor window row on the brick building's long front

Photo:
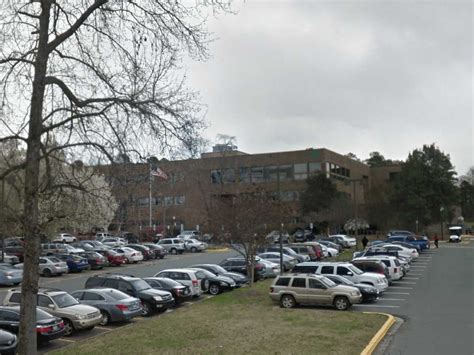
[211,162,321,184]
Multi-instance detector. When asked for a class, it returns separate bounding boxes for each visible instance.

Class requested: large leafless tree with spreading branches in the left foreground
[0,0,228,354]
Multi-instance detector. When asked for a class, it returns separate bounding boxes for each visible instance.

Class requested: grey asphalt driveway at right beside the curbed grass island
[354,241,474,355]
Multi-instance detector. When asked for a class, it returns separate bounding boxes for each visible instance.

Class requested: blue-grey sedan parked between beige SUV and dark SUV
[71,288,142,325]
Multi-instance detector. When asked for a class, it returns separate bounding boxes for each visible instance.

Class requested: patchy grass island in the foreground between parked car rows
[54,280,386,355]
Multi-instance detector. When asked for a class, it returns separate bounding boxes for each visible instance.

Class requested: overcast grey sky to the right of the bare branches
[187,0,474,174]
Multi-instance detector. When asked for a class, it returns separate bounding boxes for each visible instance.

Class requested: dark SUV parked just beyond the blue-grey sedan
[85,274,174,316]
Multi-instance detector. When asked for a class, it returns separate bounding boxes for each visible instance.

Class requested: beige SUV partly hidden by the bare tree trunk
[3,288,102,336]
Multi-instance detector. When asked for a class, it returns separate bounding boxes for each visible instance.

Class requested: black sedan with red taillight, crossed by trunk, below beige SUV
[0,305,64,344]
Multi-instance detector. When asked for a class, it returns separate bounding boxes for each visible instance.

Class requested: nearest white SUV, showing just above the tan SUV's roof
[293,261,388,293]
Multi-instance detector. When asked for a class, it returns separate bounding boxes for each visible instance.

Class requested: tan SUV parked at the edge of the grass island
[270,274,362,311]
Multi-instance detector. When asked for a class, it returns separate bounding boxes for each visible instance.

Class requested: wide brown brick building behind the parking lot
[98,147,386,233]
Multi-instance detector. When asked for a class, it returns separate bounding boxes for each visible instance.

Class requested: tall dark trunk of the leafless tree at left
[18,0,51,355]
